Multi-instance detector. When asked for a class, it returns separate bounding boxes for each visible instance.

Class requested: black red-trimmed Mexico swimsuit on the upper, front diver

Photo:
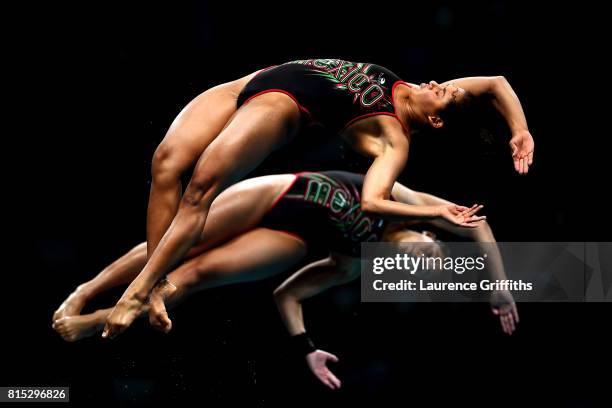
[237,59,403,132]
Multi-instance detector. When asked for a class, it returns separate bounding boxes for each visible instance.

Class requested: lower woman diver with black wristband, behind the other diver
[53,171,518,388]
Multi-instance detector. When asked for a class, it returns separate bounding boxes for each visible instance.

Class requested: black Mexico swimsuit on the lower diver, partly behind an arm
[260,171,387,257]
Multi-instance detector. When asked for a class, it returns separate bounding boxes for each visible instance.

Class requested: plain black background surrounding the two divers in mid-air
[5,1,612,407]
